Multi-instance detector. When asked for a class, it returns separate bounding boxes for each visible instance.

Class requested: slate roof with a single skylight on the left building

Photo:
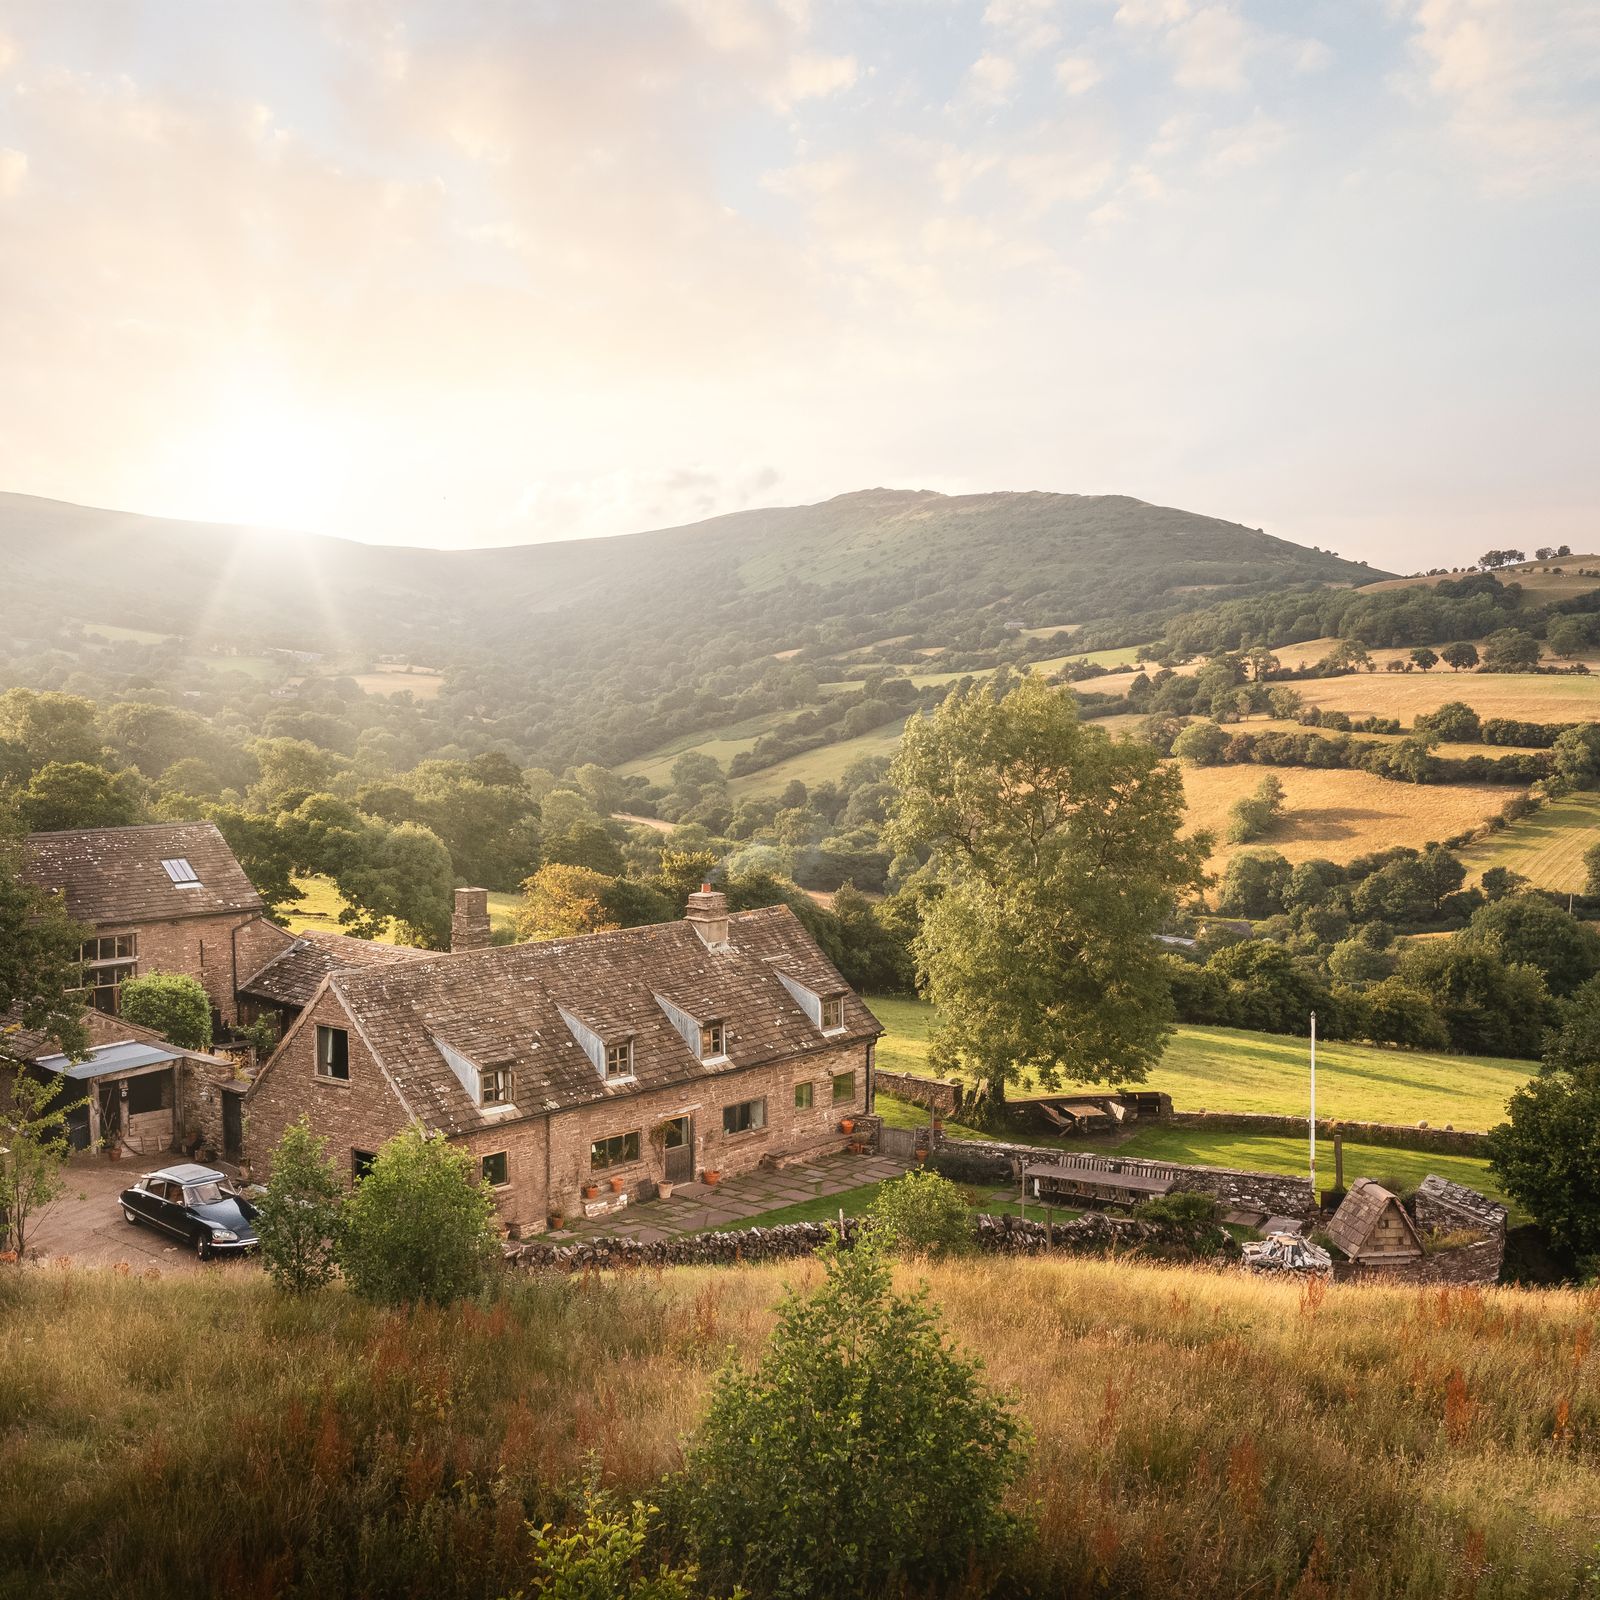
[22,822,262,926]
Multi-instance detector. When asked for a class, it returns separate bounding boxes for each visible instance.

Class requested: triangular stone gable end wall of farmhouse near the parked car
[241,990,406,1178]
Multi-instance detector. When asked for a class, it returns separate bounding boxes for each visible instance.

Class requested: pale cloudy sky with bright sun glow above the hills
[0,0,1600,571]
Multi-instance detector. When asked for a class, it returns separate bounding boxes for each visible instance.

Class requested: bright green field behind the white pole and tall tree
[867,997,1536,1130]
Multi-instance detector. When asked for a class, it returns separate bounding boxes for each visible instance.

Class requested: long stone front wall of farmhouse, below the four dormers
[489,1045,867,1232]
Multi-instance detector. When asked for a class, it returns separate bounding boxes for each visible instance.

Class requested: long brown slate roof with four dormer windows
[328,906,883,1133]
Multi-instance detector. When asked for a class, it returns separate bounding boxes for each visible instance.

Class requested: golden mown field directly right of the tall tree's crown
[1182,763,1515,872]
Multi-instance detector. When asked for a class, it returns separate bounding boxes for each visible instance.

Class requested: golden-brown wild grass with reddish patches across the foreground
[0,1261,1600,1600]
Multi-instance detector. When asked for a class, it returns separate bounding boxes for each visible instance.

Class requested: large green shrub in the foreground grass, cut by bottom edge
[680,1238,1024,1597]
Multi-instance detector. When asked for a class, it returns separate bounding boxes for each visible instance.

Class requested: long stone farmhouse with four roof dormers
[246,888,882,1234]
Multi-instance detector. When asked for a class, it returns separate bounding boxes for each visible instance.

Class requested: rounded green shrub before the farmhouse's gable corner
[338,1128,499,1306]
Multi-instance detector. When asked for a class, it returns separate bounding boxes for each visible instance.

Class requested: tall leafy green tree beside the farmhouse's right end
[888,678,1208,1094]
